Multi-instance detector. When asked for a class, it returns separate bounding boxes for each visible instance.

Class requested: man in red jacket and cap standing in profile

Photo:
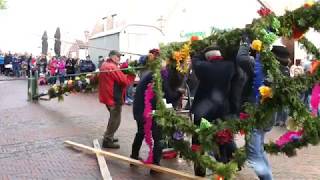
[99,50,135,149]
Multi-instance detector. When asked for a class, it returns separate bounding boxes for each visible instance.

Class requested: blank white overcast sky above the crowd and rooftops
[0,0,304,52]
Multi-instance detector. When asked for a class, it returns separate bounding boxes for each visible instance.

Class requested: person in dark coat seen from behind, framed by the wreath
[191,47,246,176]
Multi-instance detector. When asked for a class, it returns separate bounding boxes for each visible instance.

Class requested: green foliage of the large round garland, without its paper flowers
[152,3,320,179]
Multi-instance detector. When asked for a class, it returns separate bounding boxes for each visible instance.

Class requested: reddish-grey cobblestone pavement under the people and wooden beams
[0,78,320,180]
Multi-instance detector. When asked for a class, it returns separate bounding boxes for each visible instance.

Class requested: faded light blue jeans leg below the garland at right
[247,129,272,180]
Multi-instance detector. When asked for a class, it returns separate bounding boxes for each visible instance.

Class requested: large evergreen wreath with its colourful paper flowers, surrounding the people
[148,3,320,179]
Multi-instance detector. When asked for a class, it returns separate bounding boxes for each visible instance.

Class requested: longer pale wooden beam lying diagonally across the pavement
[64,141,205,179]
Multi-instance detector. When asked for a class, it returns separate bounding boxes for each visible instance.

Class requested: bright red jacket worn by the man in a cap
[99,60,135,106]
